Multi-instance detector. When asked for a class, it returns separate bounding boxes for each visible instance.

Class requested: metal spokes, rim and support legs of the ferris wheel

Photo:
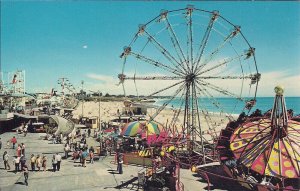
[118,5,261,163]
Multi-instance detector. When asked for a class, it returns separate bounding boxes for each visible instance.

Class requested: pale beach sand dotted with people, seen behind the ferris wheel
[73,101,236,142]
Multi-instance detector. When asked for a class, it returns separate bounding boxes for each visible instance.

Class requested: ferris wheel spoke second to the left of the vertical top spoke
[144,29,184,73]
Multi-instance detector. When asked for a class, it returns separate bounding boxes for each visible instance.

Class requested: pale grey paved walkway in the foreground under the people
[0,133,246,191]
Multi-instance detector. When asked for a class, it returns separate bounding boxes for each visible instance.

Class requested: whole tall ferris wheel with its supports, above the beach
[118,5,260,163]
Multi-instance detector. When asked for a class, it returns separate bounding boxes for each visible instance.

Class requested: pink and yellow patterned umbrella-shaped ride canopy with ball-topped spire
[230,88,300,178]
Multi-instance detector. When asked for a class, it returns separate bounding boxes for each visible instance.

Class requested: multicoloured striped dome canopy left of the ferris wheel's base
[121,121,160,136]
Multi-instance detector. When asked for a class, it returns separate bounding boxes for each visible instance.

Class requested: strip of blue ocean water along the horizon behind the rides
[155,97,300,115]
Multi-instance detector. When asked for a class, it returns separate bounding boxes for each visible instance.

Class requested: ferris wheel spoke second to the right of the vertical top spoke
[195,26,240,73]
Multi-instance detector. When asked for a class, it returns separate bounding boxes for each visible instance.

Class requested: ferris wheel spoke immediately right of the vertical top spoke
[194,11,219,72]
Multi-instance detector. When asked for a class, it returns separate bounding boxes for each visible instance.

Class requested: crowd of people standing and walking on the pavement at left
[0,125,101,185]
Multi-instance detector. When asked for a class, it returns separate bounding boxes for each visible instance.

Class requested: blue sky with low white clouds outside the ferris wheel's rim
[1,1,300,96]
